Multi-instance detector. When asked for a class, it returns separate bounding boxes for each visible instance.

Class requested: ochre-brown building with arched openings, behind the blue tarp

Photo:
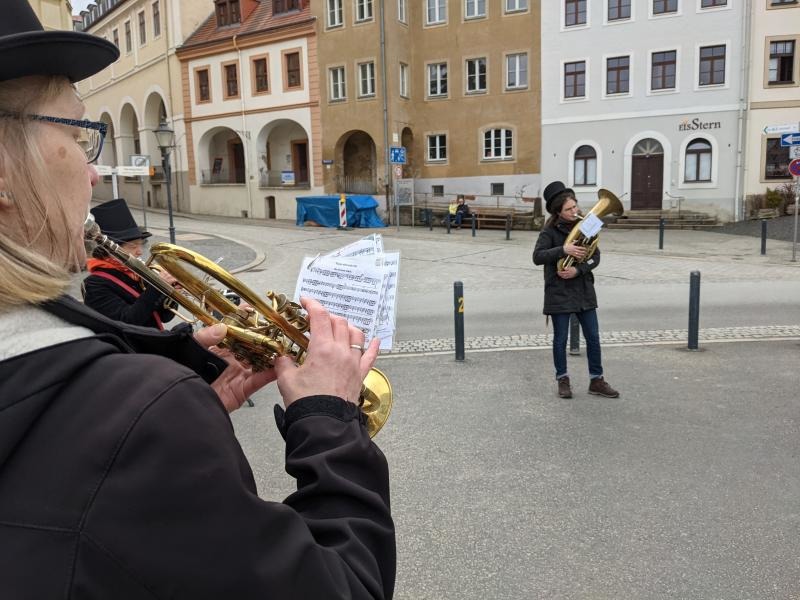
[312,0,540,213]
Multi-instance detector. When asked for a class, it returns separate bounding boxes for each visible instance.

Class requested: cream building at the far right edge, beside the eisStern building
[744,0,800,205]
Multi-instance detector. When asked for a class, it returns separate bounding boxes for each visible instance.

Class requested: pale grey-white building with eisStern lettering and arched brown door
[542,0,748,221]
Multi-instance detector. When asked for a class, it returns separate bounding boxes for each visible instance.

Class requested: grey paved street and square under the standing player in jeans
[106,211,800,600]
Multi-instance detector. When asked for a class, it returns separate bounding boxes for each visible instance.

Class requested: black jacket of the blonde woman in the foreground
[0,303,395,600]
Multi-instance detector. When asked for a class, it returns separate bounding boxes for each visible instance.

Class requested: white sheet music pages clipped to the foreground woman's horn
[294,234,400,350]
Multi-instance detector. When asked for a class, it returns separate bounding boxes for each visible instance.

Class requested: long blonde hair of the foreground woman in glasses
[0,76,79,311]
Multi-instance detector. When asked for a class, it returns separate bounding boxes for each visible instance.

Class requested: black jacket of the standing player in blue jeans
[533,219,600,315]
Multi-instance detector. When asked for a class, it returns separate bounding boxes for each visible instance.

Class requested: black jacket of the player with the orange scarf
[83,268,175,328]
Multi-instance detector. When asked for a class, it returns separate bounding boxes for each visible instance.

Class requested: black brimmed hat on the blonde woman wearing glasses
[0,0,119,82]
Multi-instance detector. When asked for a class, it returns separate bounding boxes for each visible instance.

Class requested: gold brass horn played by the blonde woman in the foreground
[84,214,393,437]
